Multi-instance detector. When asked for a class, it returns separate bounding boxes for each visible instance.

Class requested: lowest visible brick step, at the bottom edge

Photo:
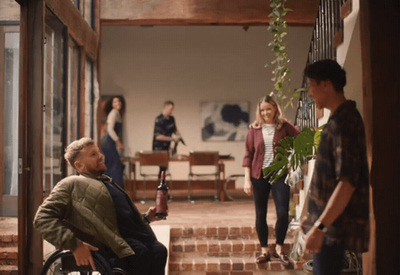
[169,257,304,275]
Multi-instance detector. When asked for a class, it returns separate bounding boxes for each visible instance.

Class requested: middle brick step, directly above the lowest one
[170,239,293,260]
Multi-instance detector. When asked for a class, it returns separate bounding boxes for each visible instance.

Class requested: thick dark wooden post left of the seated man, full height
[18,0,45,275]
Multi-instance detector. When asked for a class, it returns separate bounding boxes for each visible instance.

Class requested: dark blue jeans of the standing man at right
[313,241,345,275]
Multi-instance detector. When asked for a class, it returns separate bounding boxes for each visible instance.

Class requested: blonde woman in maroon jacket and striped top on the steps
[243,96,300,265]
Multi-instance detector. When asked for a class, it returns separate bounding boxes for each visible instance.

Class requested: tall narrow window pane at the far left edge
[0,26,19,216]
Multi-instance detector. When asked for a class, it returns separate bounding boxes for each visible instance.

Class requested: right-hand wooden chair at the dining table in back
[188,151,220,203]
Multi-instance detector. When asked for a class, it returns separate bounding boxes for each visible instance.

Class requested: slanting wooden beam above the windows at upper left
[45,0,99,60]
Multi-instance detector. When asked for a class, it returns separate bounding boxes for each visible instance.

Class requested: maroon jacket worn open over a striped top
[242,122,300,179]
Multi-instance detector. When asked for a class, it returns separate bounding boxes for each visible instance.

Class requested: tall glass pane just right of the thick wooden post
[43,12,65,194]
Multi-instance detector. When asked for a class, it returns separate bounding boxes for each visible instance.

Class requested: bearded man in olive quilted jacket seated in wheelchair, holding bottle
[34,138,168,275]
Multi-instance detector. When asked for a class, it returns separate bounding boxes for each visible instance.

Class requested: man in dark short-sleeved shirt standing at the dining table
[153,100,182,175]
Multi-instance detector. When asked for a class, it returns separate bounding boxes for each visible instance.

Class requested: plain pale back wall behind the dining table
[101,26,312,179]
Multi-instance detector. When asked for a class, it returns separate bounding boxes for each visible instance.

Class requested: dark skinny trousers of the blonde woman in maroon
[251,177,290,247]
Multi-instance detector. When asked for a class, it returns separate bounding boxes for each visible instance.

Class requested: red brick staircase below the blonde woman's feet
[169,226,304,275]
